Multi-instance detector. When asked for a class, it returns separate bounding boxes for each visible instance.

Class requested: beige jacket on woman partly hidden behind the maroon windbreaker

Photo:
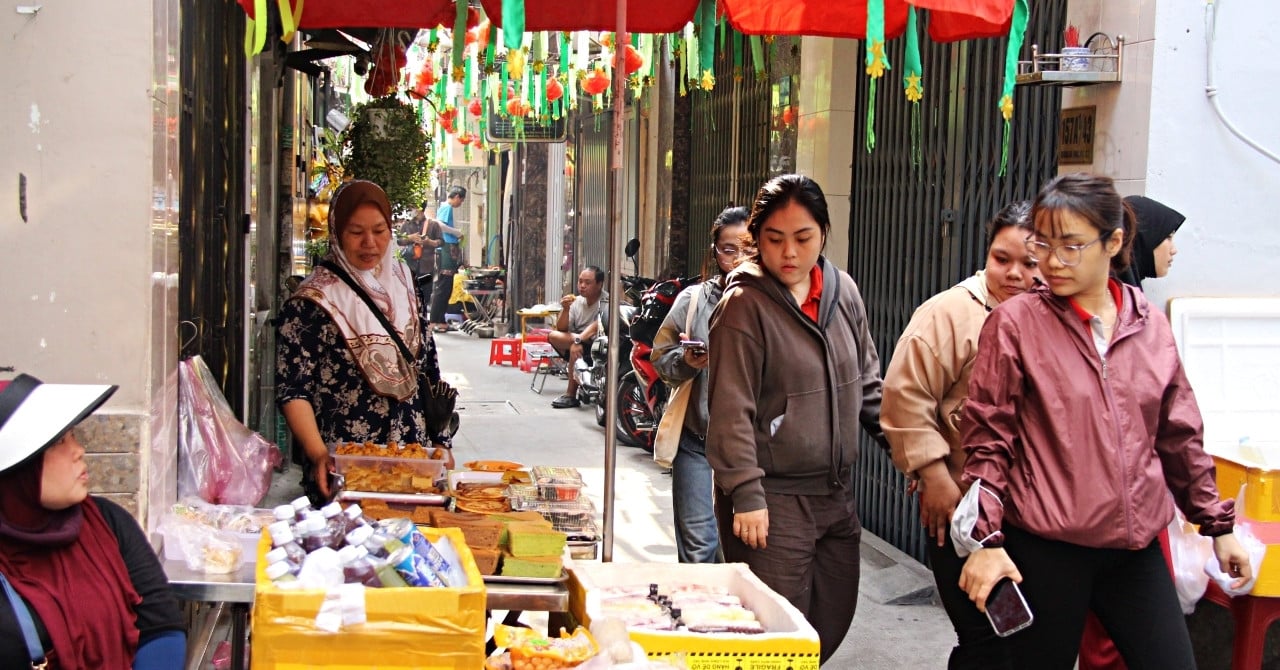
[881,270,995,482]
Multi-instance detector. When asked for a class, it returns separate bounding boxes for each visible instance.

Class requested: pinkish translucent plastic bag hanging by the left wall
[178,356,280,505]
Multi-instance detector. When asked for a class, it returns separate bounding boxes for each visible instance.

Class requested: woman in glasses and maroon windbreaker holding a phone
[952,174,1252,670]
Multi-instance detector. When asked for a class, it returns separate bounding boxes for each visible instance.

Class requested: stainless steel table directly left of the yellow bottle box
[160,560,255,670]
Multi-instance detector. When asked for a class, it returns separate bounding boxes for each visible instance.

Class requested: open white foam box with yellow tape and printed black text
[566,561,819,670]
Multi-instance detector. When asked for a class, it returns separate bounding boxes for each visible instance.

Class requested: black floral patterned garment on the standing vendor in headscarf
[275,298,449,447]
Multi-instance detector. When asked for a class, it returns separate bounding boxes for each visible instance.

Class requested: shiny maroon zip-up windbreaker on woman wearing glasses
[963,286,1235,550]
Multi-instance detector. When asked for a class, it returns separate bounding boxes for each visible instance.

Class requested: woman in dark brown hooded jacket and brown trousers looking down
[707,174,883,661]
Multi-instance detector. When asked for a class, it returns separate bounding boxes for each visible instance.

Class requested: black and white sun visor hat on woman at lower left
[0,374,118,471]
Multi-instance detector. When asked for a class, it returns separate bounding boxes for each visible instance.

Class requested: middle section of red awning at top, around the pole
[480,0,698,33]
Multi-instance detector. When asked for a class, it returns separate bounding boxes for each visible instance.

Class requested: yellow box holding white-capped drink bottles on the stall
[251,528,485,670]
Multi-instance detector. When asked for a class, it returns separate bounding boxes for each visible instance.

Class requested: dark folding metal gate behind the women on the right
[849,0,1066,561]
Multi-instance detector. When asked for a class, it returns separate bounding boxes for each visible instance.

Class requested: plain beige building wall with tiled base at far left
[0,0,166,510]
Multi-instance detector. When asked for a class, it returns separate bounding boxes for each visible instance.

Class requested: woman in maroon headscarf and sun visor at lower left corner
[0,374,187,670]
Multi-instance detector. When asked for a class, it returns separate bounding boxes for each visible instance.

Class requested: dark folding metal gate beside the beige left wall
[178,0,248,420]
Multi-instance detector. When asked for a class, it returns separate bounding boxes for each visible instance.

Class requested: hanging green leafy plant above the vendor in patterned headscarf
[342,95,431,211]
